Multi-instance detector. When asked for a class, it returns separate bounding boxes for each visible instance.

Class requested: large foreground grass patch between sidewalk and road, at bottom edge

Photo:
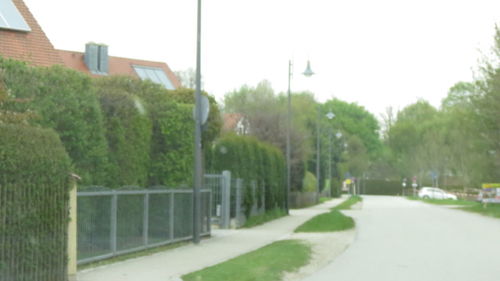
[182,240,311,281]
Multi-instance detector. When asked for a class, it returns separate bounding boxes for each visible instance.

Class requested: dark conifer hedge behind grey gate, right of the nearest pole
[207,134,285,218]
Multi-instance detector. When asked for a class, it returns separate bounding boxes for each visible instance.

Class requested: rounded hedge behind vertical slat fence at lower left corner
[0,124,71,281]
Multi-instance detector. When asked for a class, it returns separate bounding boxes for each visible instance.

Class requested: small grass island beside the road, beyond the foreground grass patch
[295,210,354,232]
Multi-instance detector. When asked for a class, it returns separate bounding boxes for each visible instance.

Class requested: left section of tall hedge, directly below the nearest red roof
[0,59,108,184]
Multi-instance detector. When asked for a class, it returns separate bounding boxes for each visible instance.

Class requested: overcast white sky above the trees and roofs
[24,0,500,116]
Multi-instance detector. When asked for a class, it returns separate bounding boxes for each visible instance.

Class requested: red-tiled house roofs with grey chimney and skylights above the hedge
[0,0,181,89]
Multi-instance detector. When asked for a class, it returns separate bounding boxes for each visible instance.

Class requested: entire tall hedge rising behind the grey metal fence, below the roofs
[0,58,222,188]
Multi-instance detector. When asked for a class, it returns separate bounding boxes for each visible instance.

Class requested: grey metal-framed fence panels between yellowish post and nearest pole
[77,188,212,264]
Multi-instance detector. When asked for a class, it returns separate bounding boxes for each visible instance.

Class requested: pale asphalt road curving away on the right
[303,196,500,281]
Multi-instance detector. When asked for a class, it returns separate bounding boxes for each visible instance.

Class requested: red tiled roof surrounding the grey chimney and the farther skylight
[57,50,181,88]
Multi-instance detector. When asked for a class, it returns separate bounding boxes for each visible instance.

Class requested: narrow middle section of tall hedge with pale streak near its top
[96,77,152,187]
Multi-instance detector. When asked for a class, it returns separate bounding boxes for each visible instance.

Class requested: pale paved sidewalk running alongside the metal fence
[77,197,346,281]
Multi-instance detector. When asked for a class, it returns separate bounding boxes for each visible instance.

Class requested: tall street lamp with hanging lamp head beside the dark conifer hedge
[285,60,314,214]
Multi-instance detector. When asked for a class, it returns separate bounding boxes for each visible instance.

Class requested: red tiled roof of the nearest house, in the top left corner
[0,0,62,66]
